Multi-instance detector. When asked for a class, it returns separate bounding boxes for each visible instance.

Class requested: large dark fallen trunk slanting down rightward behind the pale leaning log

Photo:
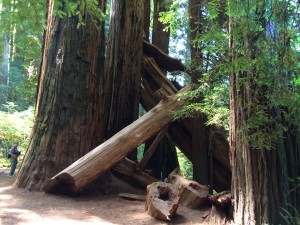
[140,57,231,191]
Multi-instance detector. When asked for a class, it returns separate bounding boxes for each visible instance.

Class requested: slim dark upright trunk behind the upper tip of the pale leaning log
[189,0,209,185]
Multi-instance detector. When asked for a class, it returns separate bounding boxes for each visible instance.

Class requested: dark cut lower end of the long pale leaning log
[44,173,77,196]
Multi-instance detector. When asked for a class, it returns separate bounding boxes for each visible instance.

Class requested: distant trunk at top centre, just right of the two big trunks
[152,0,170,54]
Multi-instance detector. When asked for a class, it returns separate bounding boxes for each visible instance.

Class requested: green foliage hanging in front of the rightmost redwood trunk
[229,3,300,149]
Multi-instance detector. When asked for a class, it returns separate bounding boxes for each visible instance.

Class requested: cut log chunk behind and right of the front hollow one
[169,175,209,209]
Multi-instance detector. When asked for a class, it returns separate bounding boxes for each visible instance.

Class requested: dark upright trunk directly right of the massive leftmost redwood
[102,0,144,160]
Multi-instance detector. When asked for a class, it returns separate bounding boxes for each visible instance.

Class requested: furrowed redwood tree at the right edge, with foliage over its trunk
[229,2,300,225]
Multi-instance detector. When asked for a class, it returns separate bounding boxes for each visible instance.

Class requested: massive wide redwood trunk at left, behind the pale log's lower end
[16,0,106,190]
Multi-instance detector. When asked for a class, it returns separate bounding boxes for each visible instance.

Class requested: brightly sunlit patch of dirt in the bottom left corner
[0,185,115,225]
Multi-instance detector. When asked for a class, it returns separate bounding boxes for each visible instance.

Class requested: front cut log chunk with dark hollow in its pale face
[146,182,179,220]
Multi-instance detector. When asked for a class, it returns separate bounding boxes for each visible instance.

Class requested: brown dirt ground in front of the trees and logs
[0,171,209,225]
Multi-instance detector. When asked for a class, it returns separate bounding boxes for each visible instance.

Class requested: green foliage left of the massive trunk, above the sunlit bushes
[0,0,46,110]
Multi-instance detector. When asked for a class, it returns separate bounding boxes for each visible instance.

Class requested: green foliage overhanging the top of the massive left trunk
[55,0,105,28]
